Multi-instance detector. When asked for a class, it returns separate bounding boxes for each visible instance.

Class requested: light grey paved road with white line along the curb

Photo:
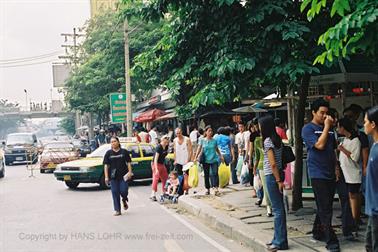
[0,165,250,252]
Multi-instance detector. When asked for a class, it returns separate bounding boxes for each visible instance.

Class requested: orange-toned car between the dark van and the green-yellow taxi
[40,142,79,173]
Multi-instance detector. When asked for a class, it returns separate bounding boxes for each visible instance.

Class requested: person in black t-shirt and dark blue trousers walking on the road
[103,137,132,216]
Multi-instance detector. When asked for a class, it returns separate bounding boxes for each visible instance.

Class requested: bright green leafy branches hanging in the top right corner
[301,0,378,64]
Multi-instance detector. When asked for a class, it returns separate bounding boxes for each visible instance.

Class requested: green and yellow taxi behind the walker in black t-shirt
[54,142,173,189]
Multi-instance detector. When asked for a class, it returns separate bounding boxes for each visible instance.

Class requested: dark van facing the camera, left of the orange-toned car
[2,133,38,165]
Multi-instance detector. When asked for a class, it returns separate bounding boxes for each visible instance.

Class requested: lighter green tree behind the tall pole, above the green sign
[66,6,164,123]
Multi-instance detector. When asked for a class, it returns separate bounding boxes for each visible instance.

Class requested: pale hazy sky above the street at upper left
[0,0,90,106]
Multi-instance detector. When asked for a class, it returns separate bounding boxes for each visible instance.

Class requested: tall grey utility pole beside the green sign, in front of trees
[124,18,133,137]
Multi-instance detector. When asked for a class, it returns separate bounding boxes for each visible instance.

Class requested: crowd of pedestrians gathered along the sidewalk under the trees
[104,99,378,251]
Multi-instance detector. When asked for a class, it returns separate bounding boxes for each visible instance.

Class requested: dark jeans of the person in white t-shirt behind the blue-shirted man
[336,171,355,236]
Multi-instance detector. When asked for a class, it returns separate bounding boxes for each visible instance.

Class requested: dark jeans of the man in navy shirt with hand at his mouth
[311,179,339,248]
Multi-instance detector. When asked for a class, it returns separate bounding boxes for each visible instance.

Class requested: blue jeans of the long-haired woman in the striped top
[265,174,288,249]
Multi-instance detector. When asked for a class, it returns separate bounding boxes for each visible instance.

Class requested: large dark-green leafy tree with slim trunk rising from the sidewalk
[126,0,330,209]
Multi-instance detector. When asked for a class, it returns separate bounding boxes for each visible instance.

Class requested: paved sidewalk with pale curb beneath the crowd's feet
[178,185,367,251]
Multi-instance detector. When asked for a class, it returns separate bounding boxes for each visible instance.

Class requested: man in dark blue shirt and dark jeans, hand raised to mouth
[302,99,340,252]
